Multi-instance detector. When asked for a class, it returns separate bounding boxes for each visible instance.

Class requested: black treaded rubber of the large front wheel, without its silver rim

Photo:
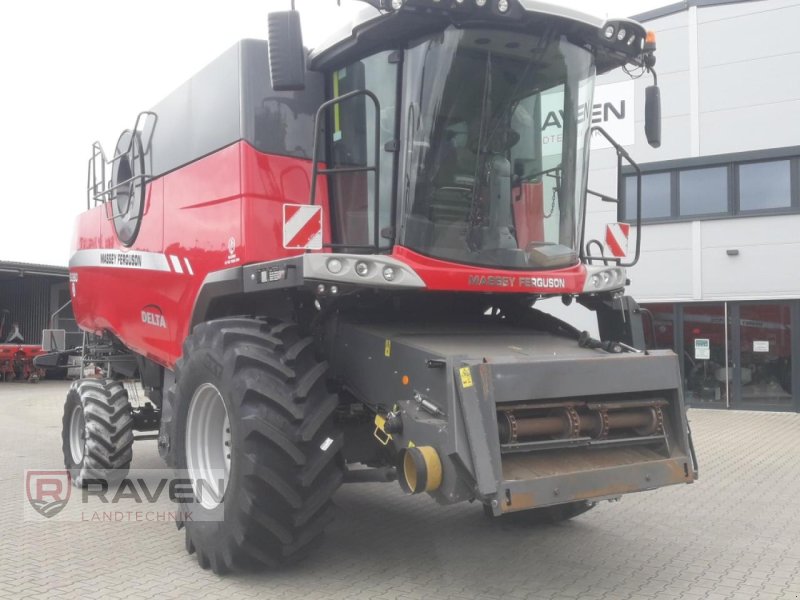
[177,317,343,574]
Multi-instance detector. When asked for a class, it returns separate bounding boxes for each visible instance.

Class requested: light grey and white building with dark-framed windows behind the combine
[576,0,800,411]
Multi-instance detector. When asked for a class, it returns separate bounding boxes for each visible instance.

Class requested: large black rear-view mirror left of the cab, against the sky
[268,10,306,92]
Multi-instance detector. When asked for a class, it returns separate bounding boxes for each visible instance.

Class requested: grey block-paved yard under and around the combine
[0,382,800,600]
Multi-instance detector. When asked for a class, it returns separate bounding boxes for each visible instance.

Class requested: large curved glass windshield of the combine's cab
[401,28,594,269]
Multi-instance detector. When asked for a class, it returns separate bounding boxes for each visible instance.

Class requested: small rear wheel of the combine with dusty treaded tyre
[61,379,133,487]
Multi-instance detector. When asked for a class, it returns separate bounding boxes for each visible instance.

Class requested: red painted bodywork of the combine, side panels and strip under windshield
[70,142,586,368]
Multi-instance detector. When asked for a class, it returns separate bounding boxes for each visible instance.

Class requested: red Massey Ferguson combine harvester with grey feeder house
[64,0,697,573]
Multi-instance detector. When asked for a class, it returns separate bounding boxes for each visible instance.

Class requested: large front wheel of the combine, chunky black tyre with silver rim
[170,318,343,574]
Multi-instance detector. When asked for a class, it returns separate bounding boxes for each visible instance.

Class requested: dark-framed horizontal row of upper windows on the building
[619,146,800,222]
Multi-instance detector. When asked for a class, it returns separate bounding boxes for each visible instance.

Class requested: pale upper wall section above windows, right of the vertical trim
[697,0,800,154]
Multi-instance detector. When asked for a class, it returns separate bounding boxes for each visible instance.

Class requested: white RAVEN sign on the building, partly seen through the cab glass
[541,81,636,156]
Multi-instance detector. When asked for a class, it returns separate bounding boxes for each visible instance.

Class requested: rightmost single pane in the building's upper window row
[739,160,792,211]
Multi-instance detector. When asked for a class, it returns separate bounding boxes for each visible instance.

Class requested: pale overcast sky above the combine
[0,0,672,265]
